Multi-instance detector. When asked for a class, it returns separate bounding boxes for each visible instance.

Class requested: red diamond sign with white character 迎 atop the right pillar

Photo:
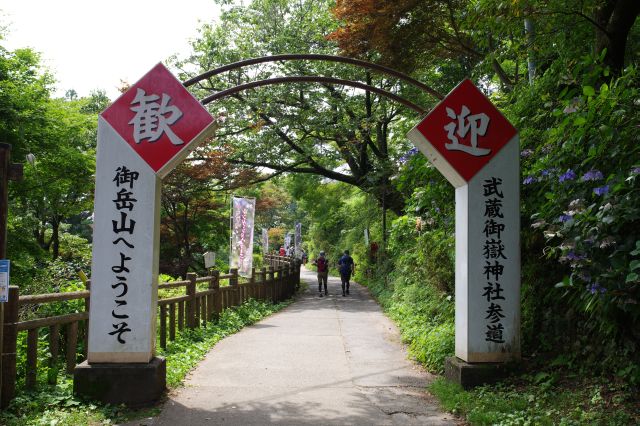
[408,80,517,187]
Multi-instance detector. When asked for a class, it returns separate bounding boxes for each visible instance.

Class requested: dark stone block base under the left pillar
[73,357,167,407]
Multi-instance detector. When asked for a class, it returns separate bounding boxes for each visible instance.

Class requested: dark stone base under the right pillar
[444,356,516,389]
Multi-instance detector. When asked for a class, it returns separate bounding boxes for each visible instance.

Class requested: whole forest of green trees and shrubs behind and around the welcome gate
[0,0,640,422]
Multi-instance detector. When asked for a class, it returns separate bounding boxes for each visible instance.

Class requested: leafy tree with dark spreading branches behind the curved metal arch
[178,0,440,213]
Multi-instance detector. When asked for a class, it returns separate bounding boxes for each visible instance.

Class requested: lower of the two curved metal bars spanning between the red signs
[200,75,427,114]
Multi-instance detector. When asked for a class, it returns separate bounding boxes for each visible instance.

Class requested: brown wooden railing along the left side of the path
[0,255,300,407]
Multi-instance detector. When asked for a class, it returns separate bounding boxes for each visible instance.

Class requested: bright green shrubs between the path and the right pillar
[358,205,454,372]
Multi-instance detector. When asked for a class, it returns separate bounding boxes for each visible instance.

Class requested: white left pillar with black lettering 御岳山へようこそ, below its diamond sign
[88,117,161,363]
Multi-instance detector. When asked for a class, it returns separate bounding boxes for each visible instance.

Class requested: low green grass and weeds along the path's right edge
[360,264,640,426]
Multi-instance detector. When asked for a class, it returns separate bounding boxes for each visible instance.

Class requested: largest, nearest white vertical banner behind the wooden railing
[229,197,256,277]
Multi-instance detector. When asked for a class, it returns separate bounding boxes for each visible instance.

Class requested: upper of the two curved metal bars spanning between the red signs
[183,54,444,100]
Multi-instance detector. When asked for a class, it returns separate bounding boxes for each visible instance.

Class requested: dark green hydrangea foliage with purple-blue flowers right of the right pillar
[510,57,640,370]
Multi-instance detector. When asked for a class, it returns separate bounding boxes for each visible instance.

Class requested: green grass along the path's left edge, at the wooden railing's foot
[0,300,290,426]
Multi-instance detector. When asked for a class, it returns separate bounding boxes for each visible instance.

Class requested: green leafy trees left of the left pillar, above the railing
[0,39,96,292]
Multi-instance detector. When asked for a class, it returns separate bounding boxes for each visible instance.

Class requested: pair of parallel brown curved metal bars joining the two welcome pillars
[183,54,444,114]
